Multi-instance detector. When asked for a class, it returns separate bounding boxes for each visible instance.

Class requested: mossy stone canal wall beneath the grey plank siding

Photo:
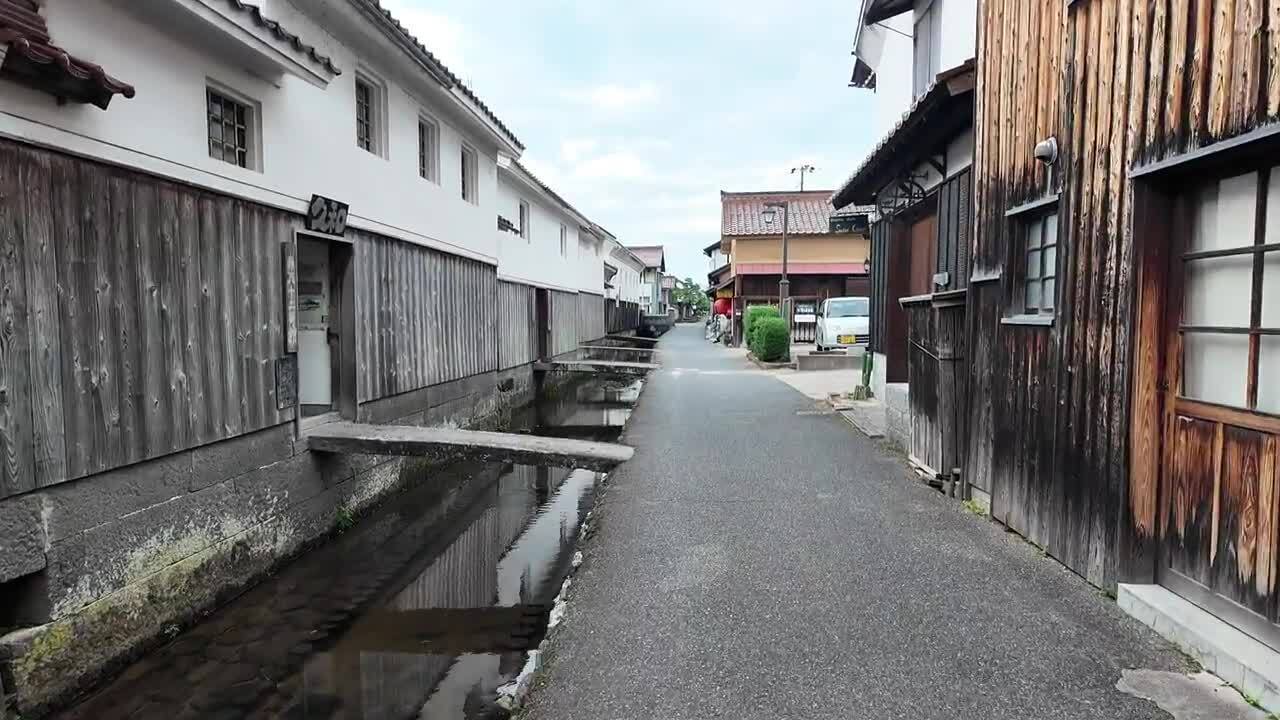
[0,365,534,717]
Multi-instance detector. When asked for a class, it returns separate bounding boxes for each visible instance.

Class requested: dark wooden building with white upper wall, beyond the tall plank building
[831,8,980,474]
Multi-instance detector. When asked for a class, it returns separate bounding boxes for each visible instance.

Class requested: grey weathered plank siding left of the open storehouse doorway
[0,140,291,497]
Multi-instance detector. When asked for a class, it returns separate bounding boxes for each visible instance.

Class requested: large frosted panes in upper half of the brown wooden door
[1179,168,1280,415]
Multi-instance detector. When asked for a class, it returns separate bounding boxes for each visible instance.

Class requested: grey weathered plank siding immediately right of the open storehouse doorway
[360,231,498,402]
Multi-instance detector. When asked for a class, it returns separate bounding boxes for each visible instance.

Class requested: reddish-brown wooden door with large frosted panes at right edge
[1158,168,1280,648]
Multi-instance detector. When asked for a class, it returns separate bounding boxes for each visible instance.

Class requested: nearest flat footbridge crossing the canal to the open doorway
[306,423,635,470]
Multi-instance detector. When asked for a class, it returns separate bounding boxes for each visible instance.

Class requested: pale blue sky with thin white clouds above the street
[381,0,878,284]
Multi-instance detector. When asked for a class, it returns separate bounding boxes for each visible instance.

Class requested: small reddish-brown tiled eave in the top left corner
[0,0,134,110]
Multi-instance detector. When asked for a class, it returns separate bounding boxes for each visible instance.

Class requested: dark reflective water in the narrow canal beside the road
[61,380,640,720]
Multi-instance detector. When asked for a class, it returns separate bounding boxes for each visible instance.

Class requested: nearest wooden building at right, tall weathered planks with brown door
[965,0,1280,648]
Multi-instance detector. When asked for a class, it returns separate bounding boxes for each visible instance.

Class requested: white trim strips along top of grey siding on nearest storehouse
[0,110,498,265]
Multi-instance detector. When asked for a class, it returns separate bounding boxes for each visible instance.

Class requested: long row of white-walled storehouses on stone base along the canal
[0,0,639,715]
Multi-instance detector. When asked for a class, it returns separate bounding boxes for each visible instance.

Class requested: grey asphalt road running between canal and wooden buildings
[526,325,1188,720]
